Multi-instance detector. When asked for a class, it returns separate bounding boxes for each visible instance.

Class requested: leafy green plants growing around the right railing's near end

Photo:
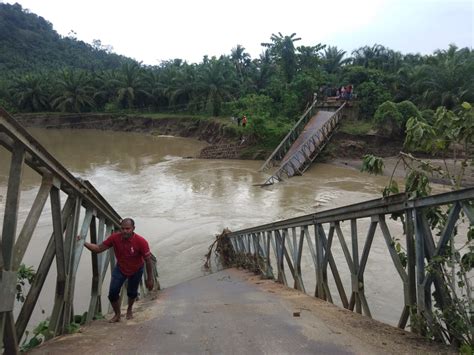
[362,102,474,354]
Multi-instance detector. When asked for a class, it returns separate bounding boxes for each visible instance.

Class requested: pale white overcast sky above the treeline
[0,0,474,65]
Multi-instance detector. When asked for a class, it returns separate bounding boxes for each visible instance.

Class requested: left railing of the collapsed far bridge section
[259,95,318,171]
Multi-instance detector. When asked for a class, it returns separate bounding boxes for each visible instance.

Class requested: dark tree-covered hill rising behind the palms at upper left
[0,3,130,76]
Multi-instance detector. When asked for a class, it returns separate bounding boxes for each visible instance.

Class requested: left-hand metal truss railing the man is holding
[0,108,157,354]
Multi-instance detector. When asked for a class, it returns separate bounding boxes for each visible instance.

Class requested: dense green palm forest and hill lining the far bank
[0,3,474,141]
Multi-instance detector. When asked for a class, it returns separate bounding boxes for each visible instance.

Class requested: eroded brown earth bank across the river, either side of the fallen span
[14,113,402,161]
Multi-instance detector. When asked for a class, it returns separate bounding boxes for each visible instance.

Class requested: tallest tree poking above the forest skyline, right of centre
[262,32,301,83]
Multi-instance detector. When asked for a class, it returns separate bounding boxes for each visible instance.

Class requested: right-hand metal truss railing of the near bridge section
[228,188,474,341]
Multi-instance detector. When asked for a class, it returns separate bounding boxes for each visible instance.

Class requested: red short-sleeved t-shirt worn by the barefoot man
[104,232,151,276]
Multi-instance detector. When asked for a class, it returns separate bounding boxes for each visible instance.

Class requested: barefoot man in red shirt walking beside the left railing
[84,218,153,323]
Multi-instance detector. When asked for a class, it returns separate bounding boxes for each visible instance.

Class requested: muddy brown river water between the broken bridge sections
[0,128,452,330]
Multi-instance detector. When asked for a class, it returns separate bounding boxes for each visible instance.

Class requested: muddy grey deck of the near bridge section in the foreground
[31,269,449,354]
